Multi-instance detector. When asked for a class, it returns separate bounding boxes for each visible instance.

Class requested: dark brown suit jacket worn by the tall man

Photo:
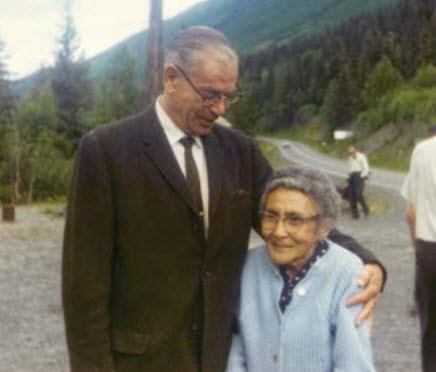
[62,108,382,372]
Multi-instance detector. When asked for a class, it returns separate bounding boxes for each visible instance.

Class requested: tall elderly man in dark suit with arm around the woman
[63,27,382,372]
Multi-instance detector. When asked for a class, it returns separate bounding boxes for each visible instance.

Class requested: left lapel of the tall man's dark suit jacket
[142,109,195,211]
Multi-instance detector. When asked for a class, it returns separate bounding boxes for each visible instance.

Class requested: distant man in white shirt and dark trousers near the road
[348,147,369,218]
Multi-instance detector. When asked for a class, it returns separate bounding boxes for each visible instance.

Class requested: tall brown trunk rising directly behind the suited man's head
[144,0,163,105]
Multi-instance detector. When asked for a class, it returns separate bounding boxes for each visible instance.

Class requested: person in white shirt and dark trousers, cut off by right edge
[401,126,436,372]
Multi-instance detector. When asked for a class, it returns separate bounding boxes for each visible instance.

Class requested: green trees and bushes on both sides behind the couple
[0,0,436,203]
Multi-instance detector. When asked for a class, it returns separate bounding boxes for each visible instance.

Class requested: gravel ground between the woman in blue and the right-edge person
[338,187,421,372]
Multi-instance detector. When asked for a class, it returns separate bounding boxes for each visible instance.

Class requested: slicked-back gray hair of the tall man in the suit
[165,26,238,74]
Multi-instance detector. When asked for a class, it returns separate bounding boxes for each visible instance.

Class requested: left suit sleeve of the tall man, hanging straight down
[62,132,115,372]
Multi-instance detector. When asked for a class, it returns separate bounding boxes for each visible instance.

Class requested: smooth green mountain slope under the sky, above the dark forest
[13,0,397,96]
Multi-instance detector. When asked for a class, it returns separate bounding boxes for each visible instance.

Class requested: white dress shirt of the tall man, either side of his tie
[155,97,209,236]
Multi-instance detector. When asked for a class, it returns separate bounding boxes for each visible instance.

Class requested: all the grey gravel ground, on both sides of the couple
[0,181,420,372]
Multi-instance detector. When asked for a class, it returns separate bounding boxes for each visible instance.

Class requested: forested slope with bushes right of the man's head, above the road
[231,0,436,171]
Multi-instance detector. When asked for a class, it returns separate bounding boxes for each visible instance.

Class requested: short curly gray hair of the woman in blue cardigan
[260,166,340,228]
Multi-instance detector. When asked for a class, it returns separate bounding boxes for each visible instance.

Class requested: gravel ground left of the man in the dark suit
[0,206,68,372]
